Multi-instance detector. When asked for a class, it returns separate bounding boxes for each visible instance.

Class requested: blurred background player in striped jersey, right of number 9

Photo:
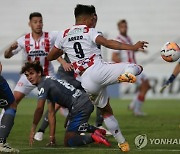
[112,19,150,116]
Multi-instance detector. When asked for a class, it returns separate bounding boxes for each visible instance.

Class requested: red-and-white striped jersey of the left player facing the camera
[13,31,58,76]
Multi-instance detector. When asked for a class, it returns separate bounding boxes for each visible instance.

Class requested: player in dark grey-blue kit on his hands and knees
[22,62,110,147]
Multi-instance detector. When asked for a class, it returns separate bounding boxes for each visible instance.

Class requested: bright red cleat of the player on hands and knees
[91,129,111,147]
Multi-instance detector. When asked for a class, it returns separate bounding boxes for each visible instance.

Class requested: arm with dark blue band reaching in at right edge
[160,63,180,93]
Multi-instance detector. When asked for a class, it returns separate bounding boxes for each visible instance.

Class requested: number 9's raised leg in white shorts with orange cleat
[81,61,143,94]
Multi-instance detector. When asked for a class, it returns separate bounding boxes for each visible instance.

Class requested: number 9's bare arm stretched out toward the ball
[96,35,148,51]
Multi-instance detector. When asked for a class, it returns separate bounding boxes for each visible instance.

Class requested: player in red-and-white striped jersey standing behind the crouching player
[4,12,58,109]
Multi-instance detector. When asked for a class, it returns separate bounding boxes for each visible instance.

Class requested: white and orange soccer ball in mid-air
[161,42,180,62]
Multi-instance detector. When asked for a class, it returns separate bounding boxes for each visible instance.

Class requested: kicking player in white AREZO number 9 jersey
[48,4,146,151]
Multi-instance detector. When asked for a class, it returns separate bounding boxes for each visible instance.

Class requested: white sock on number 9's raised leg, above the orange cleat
[124,64,142,75]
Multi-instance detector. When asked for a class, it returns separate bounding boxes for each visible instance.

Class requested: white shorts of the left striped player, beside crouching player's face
[14,74,36,95]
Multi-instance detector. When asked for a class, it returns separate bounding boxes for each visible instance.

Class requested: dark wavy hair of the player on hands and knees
[21,61,44,76]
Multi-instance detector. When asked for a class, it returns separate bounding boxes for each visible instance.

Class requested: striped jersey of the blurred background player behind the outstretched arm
[113,34,136,64]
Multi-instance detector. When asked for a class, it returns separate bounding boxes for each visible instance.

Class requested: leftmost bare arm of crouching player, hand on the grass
[29,99,46,146]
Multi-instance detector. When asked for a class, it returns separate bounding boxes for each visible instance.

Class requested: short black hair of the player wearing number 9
[74,4,96,18]
